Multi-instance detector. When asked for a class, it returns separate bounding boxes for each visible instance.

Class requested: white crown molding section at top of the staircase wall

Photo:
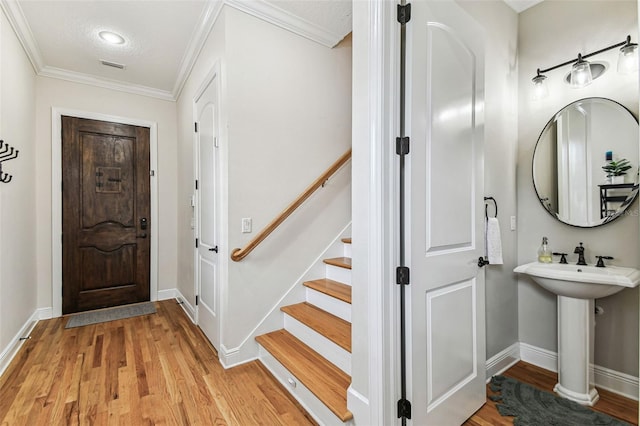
[224,0,345,48]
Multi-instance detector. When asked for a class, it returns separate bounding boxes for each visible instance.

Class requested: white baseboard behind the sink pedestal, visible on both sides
[520,343,639,401]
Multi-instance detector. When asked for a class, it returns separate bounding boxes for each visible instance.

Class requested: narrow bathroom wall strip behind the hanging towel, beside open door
[459,1,518,359]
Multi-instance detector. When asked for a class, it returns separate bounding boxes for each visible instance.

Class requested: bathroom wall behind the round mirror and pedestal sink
[517,1,640,376]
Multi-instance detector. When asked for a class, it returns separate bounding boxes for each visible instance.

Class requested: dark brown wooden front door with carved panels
[62,117,151,314]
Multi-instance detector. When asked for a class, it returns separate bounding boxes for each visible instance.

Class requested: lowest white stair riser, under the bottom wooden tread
[258,346,353,426]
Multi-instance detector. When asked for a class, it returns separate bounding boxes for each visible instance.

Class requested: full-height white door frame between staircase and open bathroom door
[347,0,400,425]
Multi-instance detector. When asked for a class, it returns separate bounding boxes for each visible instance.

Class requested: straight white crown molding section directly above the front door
[38,66,175,101]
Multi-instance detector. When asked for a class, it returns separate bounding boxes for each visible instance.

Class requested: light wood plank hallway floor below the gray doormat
[0,300,315,426]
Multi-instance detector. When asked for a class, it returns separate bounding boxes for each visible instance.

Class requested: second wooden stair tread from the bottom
[280,302,351,353]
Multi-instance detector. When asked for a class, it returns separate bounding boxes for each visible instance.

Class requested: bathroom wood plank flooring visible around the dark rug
[464,361,638,426]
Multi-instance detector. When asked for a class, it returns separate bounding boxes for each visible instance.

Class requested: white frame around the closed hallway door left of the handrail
[192,61,229,346]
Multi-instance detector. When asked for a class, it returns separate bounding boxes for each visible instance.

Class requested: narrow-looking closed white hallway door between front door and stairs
[195,74,220,349]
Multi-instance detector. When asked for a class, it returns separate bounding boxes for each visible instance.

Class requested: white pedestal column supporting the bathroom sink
[553,296,600,406]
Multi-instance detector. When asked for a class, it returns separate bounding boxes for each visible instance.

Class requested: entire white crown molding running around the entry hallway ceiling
[0,0,344,101]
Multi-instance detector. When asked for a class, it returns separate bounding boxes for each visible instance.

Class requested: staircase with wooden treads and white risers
[256,238,353,424]
